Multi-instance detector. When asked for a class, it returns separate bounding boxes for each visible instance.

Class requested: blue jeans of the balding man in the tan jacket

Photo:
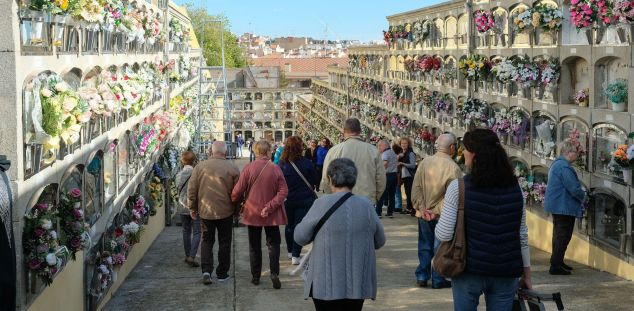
[415,218,445,286]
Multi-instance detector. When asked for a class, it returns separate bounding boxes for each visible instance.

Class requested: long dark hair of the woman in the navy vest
[463,129,517,188]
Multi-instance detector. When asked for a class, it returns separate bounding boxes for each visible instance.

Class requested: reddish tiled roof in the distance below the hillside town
[249,57,348,78]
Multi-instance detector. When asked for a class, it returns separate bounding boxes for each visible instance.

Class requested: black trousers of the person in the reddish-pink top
[248,226,282,279]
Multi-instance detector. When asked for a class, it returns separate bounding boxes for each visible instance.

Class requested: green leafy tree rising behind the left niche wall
[185,3,246,68]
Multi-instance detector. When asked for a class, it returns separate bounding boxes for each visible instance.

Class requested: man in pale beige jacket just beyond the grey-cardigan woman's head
[320,118,386,202]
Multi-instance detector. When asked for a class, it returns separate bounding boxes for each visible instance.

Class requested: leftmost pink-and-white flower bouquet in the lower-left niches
[22,203,67,286]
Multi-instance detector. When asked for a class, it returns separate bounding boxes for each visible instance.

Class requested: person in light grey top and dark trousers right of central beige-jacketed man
[376,140,398,218]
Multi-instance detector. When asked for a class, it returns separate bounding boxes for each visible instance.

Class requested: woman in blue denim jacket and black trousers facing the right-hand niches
[544,139,586,275]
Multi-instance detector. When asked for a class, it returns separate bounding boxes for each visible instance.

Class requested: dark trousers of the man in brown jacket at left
[200,216,233,278]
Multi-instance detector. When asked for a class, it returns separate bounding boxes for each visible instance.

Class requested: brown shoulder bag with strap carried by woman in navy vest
[431,178,467,278]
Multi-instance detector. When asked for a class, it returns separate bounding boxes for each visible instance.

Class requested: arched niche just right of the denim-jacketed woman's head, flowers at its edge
[592,123,627,183]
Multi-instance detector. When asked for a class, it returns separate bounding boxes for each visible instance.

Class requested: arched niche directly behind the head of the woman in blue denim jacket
[559,117,590,171]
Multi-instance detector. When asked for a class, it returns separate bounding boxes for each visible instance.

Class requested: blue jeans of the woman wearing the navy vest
[451,272,519,311]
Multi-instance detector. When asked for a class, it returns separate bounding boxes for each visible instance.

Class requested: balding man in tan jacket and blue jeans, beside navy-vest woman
[412,134,462,289]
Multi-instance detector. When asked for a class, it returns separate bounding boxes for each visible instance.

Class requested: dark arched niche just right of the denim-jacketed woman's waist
[588,188,627,250]
